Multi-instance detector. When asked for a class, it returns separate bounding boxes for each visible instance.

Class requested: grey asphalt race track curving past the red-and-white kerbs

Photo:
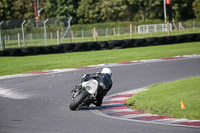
[0,58,200,133]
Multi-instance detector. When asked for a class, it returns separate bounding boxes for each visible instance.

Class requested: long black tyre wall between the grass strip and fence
[0,33,200,56]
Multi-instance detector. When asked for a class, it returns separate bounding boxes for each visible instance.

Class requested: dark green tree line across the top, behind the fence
[0,0,200,24]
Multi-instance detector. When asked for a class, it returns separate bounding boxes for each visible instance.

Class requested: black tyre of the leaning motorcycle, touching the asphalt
[69,90,89,110]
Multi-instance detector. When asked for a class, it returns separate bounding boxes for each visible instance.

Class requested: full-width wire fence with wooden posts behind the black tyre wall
[0,18,200,50]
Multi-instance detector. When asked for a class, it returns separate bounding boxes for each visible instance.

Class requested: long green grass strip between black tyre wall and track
[0,42,200,76]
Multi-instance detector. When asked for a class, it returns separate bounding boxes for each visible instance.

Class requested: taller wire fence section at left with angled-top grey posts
[0,18,70,49]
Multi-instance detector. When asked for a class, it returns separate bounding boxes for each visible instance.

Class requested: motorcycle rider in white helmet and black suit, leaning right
[72,68,112,107]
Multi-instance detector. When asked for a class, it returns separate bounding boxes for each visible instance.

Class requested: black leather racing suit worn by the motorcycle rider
[81,73,112,106]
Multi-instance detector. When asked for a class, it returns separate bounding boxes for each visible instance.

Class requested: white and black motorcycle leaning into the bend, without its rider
[69,79,98,110]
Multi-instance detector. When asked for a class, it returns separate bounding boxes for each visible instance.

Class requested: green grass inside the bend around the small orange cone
[126,77,200,119]
